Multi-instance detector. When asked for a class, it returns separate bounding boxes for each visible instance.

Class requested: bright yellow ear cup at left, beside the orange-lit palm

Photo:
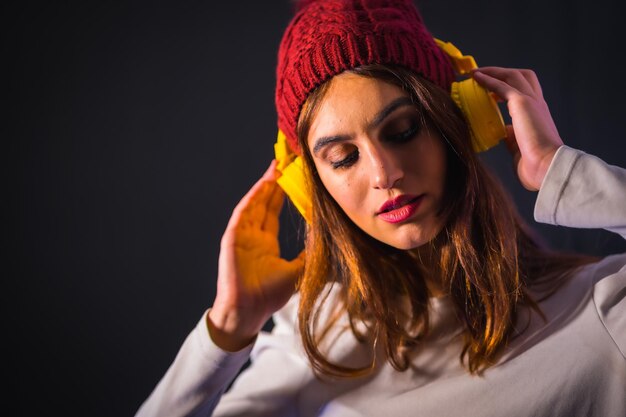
[274,130,312,223]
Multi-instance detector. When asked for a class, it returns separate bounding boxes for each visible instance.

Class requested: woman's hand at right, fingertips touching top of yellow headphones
[473,67,563,191]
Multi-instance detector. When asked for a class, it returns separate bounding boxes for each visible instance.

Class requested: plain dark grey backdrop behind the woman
[6,0,626,416]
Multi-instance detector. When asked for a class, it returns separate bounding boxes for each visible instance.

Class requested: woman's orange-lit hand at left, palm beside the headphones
[207,161,304,352]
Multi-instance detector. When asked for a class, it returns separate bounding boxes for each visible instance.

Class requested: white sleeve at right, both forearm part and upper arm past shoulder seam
[535,146,626,357]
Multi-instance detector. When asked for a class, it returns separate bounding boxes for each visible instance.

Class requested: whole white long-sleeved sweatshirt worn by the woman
[136,146,626,417]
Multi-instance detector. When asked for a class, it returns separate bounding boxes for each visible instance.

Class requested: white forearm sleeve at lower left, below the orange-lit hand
[135,311,252,417]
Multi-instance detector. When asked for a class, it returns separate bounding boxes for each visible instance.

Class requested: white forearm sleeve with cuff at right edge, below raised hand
[535,145,626,239]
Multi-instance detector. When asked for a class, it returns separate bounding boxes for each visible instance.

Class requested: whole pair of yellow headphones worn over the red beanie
[274,39,506,224]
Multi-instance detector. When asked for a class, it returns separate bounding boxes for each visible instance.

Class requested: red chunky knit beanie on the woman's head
[276,0,454,154]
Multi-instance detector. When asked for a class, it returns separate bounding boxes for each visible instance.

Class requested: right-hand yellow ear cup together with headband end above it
[435,39,506,152]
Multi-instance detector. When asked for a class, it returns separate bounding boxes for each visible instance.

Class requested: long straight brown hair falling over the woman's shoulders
[297,64,594,376]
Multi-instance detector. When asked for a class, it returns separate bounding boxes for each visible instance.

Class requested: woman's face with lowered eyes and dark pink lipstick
[308,72,446,249]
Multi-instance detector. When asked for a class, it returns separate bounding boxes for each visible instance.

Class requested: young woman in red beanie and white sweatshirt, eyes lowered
[137,0,626,417]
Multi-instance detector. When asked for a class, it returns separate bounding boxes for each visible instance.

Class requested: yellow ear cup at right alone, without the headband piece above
[451,79,506,152]
